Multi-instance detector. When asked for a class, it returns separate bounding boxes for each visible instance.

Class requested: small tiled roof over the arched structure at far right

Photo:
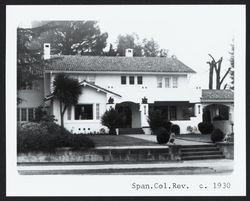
[201,89,234,102]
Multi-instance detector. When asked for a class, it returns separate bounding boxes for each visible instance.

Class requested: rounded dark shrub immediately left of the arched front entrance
[101,108,122,135]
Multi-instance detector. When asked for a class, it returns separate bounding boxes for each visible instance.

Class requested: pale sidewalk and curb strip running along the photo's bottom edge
[17,159,233,175]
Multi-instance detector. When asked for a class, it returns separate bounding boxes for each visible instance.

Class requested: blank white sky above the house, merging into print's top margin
[16,5,242,88]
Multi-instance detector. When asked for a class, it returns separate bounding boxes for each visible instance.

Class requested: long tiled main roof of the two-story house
[45,55,196,73]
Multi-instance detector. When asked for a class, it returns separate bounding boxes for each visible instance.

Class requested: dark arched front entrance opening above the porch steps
[115,101,141,128]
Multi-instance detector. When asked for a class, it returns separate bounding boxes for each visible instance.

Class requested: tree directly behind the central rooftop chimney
[116,33,142,56]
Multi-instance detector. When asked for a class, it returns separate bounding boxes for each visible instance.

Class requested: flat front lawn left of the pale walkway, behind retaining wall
[86,135,157,147]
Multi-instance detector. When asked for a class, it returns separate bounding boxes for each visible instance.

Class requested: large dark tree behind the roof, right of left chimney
[39,21,108,55]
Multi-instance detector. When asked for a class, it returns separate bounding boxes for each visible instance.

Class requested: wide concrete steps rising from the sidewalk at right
[181,144,225,160]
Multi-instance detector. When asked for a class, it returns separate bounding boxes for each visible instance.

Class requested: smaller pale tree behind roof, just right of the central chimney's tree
[142,38,160,57]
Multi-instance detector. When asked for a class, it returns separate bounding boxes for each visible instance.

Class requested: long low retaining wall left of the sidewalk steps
[17,145,180,163]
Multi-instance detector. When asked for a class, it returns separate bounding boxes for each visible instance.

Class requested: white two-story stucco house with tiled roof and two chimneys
[17,44,207,133]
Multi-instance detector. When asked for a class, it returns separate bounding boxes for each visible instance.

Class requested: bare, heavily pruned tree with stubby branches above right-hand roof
[207,54,231,89]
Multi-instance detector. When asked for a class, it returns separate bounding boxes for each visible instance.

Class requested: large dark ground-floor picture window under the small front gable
[75,104,93,120]
